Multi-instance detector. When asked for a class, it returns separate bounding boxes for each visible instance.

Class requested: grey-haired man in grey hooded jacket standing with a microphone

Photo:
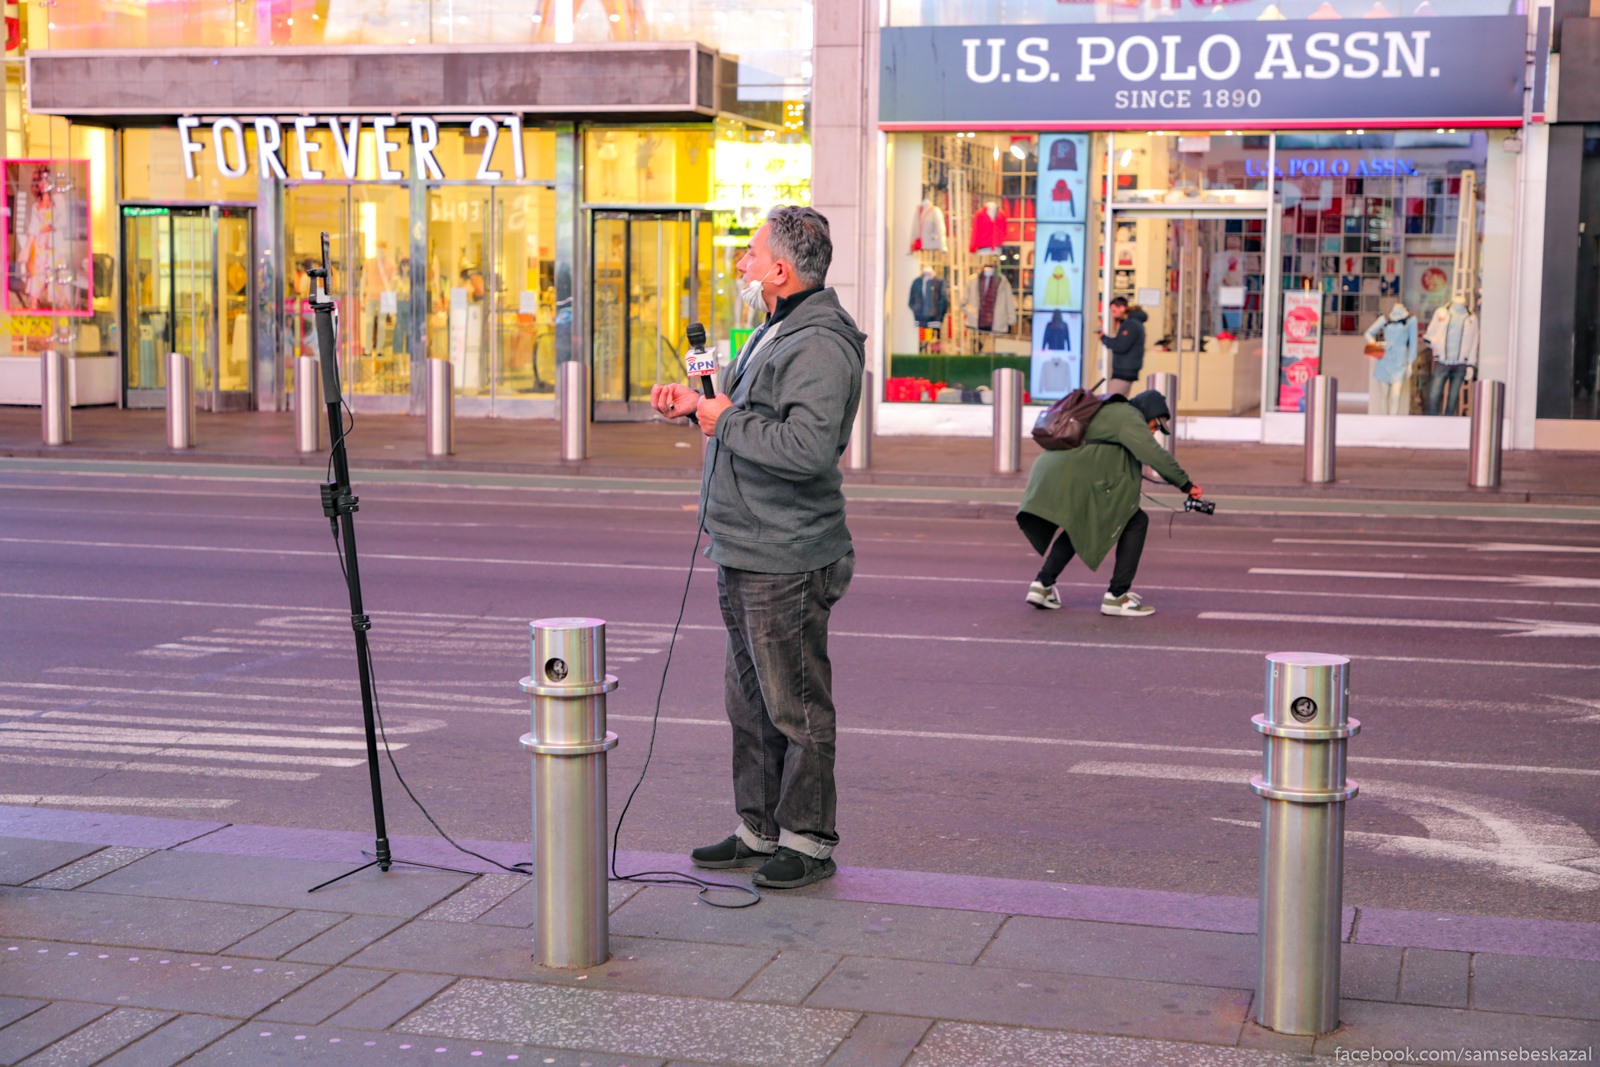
[650,206,866,889]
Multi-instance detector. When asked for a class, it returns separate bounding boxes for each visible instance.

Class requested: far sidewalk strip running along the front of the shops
[0,408,1600,509]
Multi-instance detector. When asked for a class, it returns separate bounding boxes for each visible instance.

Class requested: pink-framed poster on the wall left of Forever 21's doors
[0,160,94,315]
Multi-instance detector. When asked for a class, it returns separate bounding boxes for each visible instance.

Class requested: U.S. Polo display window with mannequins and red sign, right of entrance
[1269,130,1504,416]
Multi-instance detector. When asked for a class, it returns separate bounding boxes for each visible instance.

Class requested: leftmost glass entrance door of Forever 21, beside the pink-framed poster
[122,205,254,411]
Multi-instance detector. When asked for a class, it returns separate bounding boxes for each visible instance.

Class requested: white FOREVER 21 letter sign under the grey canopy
[178,115,528,181]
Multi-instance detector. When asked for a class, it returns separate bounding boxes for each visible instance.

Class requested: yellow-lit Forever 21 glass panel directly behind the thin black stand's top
[282,182,411,411]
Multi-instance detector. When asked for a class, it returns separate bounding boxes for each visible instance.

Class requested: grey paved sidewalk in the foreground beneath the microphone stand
[0,812,1600,1067]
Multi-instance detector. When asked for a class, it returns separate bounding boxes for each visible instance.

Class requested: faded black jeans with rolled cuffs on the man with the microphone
[717,550,856,859]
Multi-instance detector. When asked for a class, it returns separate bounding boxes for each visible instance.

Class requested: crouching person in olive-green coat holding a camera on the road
[1016,389,1202,619]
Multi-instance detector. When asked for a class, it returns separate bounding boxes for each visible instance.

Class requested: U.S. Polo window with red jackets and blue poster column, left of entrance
[883,131,1104,405]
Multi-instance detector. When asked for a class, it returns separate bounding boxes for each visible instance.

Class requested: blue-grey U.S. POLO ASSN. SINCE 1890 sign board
[880,16,1526,130]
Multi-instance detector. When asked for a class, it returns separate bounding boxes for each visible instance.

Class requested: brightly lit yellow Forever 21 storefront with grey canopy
[0,0,813,419]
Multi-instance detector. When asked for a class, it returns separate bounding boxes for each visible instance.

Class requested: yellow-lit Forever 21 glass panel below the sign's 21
[426,186,555,414]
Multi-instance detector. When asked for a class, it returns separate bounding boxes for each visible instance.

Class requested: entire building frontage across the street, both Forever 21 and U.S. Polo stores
[0,0,1600,450]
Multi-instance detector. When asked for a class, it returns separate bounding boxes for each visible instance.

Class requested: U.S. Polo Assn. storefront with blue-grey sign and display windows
[878,0,1600,448]
